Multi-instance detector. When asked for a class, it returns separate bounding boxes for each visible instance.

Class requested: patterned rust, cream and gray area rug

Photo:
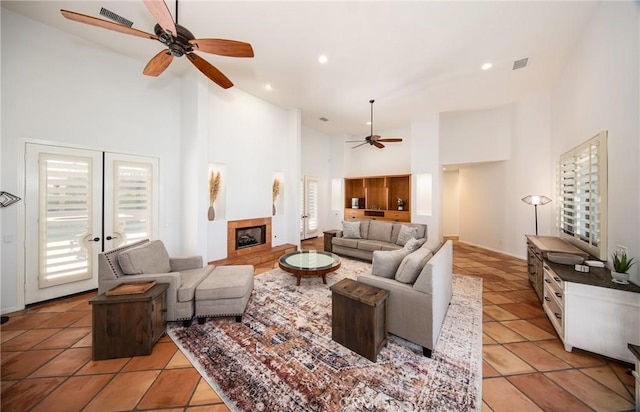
[167,258,482,411]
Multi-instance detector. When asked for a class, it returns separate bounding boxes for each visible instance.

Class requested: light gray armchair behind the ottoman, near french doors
[98,239,214,324]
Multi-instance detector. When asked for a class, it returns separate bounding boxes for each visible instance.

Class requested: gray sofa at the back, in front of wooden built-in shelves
[331,219,427,261]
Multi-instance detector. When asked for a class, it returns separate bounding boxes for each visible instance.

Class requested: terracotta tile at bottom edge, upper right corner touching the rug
[138,368,200,409]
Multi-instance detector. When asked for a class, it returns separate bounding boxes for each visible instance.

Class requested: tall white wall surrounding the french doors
[0,9,181,313]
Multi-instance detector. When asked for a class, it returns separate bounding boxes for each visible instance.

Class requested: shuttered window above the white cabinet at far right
[558,132,607,260]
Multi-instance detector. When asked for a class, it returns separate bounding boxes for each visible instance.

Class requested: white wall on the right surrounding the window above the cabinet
[551,2,640,283]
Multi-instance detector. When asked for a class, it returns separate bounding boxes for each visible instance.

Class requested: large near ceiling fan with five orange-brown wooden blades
[60,0,253,89]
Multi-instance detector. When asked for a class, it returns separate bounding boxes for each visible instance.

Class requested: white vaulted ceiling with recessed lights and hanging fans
[2,0,598,135]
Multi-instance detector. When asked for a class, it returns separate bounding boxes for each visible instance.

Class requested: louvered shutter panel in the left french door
[38,154,93,288]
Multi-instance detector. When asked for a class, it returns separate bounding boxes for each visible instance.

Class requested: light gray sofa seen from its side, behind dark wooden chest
[357,240,453,357]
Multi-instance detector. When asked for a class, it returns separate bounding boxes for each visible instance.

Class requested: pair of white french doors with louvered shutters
[24,143,158,304]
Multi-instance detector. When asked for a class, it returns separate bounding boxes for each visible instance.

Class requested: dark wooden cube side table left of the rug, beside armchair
[89,283,169,360]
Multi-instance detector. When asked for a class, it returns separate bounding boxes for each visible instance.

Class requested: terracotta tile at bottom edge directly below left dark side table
[84,370,160,412]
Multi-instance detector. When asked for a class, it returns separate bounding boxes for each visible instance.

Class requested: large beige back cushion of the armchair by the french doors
[118,240,171,275]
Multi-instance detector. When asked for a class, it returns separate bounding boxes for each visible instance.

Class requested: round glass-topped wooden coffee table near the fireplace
[278,250,340,286]
